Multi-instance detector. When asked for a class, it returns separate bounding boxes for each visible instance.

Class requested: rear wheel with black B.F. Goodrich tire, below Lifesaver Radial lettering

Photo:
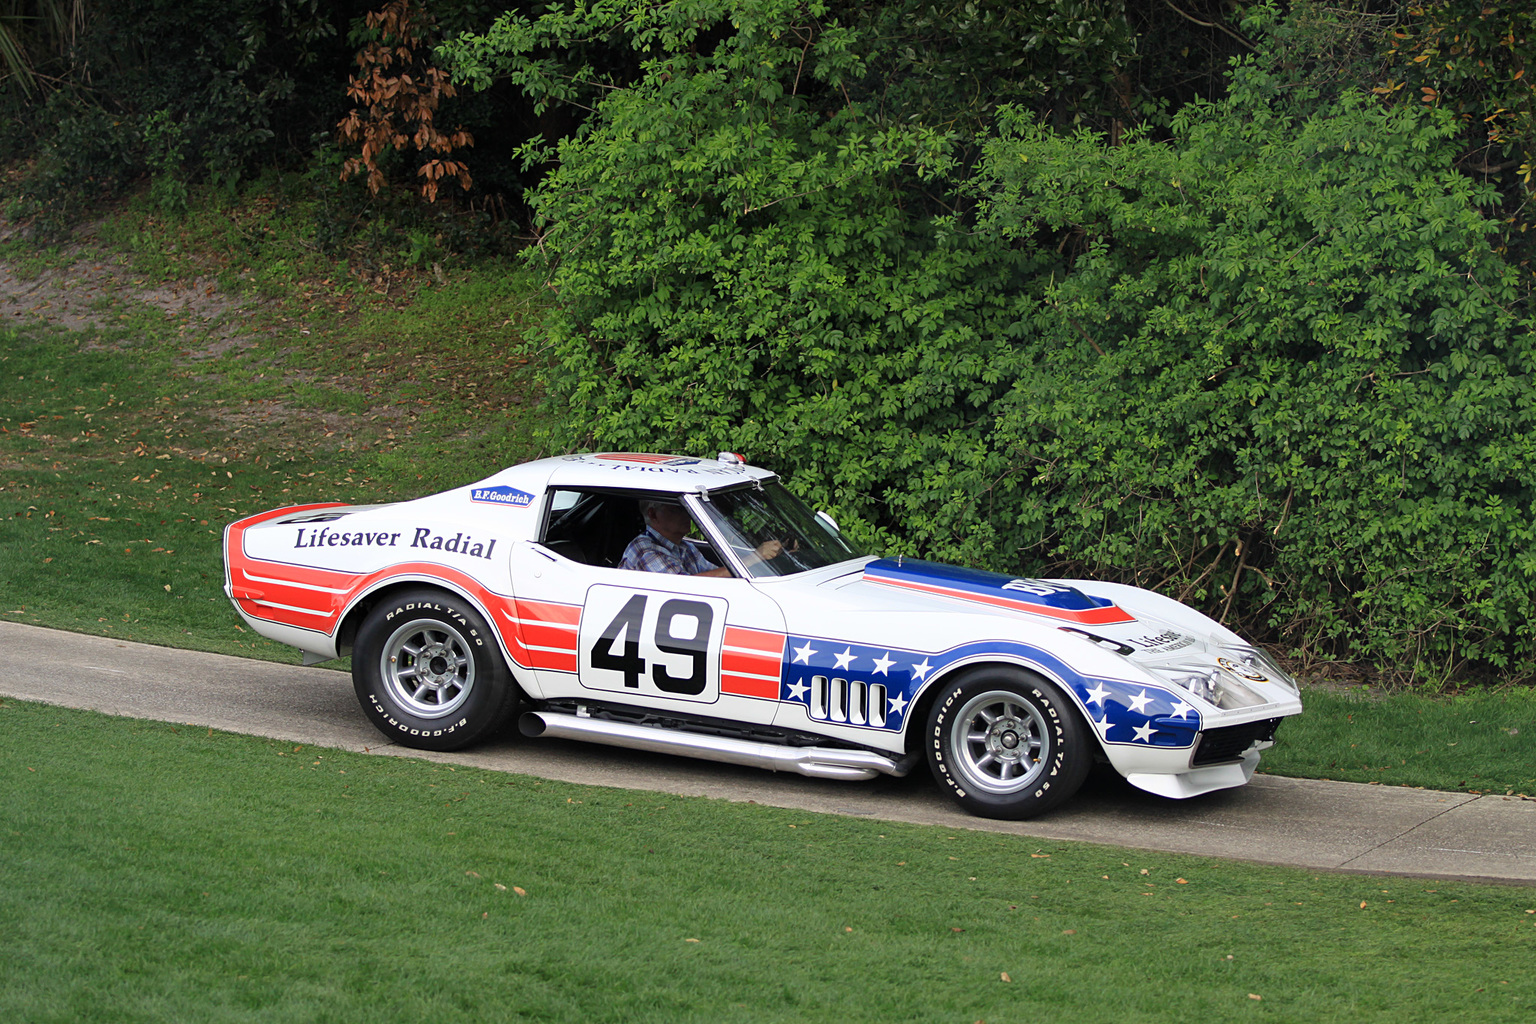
[352,590,518,751]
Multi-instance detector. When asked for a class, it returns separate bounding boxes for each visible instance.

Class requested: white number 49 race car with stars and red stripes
[224,451,1301,818]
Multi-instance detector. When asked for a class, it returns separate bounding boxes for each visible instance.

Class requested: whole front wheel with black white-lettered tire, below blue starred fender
[925,666,1094,820]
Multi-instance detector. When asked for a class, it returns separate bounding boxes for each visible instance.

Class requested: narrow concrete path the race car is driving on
[0,622,1536,884]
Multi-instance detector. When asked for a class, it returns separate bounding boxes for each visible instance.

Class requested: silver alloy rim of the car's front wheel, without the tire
[949,689,1049,795]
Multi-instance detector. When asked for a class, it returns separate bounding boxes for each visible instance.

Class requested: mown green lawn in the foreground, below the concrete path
[0,700,1536,1024]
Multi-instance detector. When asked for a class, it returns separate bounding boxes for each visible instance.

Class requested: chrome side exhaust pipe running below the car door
[518,711,912,780]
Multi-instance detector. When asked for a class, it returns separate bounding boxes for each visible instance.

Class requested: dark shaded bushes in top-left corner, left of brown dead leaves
[0,0,366,229]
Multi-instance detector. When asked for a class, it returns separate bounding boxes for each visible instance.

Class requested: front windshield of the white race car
[700,481,860,576]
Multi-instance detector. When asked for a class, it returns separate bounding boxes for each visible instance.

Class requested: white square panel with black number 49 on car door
[578,586,727,703]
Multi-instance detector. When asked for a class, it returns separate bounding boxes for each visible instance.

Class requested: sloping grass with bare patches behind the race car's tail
[0,188,544,657]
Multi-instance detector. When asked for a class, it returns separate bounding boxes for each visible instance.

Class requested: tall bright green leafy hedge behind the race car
[449,0,1536,677]
